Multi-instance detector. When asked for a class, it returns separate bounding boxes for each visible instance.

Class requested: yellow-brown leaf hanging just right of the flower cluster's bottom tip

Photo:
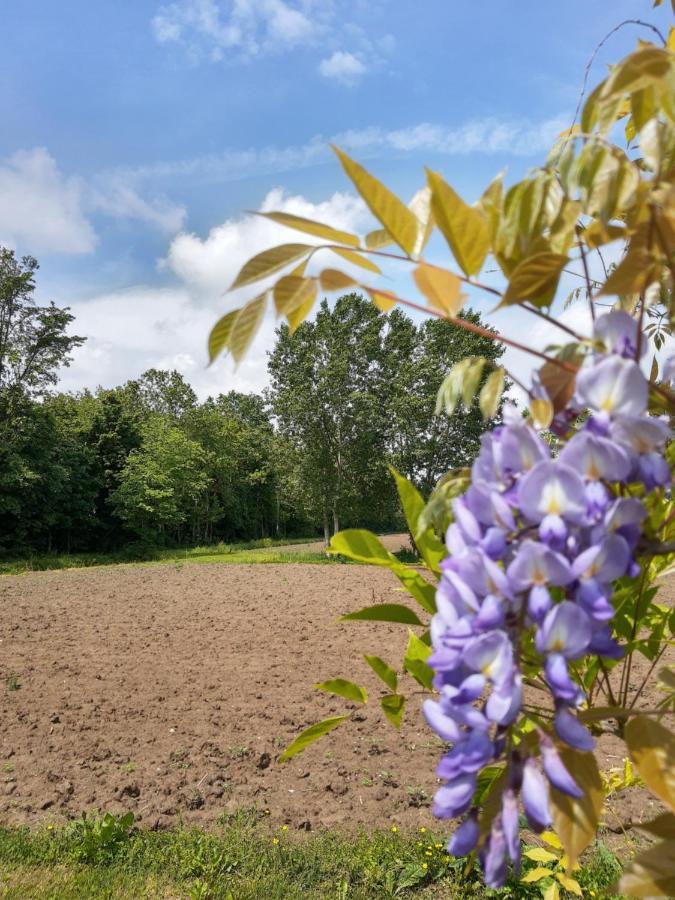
[551,748,604,870]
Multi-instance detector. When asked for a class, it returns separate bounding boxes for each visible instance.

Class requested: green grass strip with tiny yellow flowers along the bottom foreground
[0,811,620,900]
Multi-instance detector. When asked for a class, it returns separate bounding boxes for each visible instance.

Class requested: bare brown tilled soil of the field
[0,535,672,831]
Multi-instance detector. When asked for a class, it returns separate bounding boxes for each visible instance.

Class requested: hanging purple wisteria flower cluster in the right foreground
[424,312,670,887]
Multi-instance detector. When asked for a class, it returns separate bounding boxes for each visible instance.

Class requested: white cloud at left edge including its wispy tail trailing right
[0,147,185,254]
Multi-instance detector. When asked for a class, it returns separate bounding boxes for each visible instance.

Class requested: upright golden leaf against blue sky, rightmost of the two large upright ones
[427,170,490,275]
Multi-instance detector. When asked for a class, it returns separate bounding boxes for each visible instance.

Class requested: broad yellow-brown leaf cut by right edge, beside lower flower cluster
[625,716,675,811]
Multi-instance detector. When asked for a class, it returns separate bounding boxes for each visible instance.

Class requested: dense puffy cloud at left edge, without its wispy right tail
[0,147,96,254]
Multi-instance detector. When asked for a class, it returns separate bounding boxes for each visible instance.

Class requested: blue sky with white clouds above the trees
[0,0,671,395]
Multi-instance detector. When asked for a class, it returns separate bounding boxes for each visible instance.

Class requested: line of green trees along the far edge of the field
[0,249,500,555]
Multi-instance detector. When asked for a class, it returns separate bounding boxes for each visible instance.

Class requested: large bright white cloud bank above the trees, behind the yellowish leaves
[60,188,368,397]
